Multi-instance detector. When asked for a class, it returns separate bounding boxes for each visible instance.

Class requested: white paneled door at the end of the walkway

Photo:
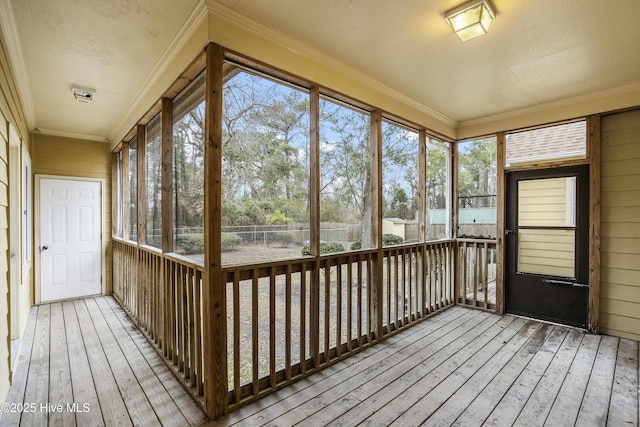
[39,178,102,302]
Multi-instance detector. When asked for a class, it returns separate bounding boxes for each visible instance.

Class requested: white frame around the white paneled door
[33,174,107,304]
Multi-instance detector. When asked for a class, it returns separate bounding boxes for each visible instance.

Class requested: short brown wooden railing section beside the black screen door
[457,239,497,310]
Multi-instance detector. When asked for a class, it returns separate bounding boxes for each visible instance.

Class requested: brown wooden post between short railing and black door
[496,132,507,314]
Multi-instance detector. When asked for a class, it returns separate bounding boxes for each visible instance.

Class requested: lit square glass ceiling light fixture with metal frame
[444,0,496,42]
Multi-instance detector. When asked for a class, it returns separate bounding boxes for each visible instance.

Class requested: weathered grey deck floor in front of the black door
[211,307,640,427]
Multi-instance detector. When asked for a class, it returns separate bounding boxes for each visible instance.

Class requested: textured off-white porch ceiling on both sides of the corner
[0,0,640,139]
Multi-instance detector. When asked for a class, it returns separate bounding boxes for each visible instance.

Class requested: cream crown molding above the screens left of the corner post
[107,0,209,143]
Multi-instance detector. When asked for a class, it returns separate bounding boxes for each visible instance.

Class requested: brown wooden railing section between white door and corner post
[113,239,204,401]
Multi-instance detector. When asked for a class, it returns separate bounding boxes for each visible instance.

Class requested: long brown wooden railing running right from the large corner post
[223,241,455,410]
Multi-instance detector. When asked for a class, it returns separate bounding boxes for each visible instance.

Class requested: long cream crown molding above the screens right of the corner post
[205,0,458,128]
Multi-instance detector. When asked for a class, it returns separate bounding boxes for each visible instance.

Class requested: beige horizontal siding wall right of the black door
[600,110,640,340]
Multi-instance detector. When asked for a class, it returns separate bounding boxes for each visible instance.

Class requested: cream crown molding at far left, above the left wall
[0,0,35,129]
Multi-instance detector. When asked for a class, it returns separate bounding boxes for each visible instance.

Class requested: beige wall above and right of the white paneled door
[32,134,112,293]
